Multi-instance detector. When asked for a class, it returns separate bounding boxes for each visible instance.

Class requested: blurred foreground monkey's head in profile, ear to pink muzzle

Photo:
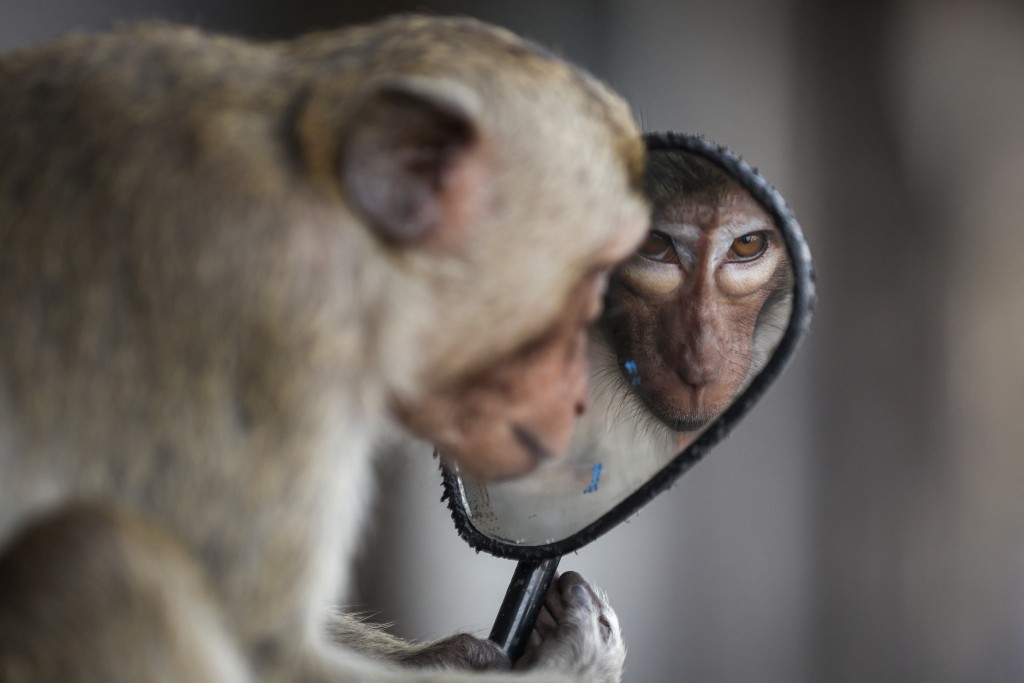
[319,21,649,478]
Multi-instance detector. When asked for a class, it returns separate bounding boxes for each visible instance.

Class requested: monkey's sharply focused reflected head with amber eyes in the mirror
[594,151,793,447]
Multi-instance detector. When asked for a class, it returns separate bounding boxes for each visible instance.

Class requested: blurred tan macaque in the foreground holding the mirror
[0,16,649,683]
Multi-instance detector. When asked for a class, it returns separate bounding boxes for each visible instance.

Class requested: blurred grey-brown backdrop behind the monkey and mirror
[0,0,1024,683]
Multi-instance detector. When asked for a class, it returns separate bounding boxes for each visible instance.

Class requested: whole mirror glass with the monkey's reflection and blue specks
[456,148,794,546]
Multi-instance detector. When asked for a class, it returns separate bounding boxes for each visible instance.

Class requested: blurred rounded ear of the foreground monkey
[340,79,480,245]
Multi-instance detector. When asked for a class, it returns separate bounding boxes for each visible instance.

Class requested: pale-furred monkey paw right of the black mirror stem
[515,571,626,683]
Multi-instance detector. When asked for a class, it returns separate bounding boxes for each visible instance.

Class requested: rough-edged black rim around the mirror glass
[441,132,816,562]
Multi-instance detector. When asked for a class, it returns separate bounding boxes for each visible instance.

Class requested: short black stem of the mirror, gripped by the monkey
[489,557,562,664]
